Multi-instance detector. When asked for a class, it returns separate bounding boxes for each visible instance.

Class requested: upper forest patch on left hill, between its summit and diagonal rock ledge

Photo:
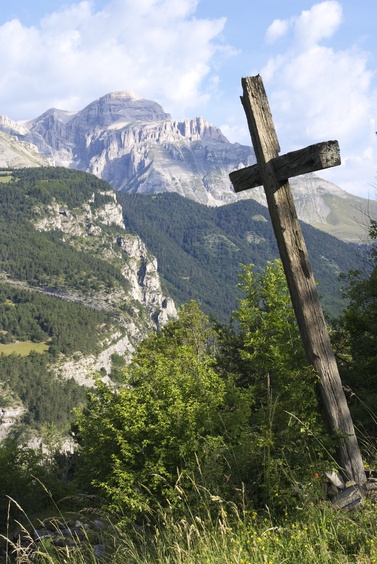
[0,168,127,293]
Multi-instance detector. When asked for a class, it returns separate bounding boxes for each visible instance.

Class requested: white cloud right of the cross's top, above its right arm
[261,1,377,196]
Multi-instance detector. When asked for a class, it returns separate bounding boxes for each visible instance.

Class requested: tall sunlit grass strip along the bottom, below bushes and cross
[3,392,377,564]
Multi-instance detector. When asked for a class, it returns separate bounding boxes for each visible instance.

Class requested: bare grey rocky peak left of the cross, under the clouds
[0,92,253,204]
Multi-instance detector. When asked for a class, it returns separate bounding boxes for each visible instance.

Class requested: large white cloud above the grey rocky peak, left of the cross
[0,0,231,119]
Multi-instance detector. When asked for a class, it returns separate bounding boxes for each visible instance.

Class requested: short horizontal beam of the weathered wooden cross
[229,141,341,192]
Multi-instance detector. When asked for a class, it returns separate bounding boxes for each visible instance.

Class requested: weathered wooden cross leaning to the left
[230,76,366,484]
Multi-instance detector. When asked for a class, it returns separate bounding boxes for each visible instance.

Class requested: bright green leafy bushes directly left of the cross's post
[74,262,328,518]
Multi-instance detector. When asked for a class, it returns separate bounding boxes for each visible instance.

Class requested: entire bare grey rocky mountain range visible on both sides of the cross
[0,91,377,243]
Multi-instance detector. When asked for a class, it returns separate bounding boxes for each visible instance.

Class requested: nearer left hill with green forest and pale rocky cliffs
[0,167,176,439]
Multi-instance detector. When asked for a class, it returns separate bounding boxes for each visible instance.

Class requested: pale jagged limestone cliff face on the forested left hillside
[34,190,177,386]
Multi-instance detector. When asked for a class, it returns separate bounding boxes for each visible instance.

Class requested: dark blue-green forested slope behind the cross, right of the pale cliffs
[121,194,365,321]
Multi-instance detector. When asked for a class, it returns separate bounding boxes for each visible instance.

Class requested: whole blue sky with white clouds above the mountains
[0,0,377,198]
